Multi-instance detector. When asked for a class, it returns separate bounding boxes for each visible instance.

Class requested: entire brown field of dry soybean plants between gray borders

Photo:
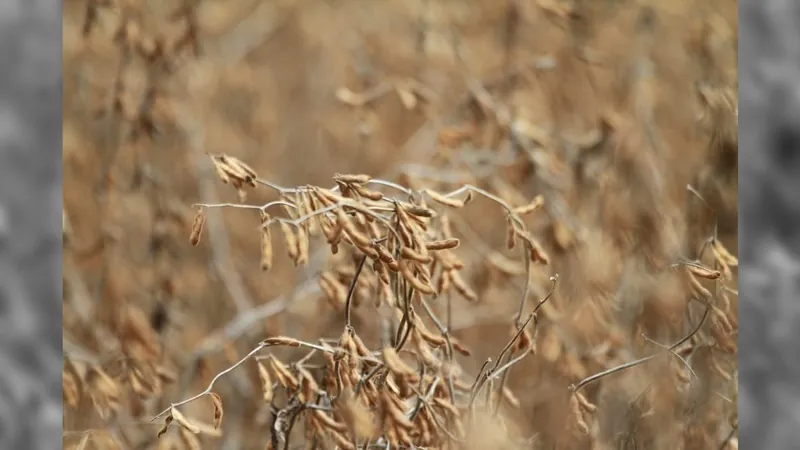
[63,0,738,450]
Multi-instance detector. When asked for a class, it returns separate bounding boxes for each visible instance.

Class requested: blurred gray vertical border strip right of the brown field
[739,0,800,449]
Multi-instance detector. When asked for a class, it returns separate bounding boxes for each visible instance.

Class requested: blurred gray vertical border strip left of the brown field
[0,0,63,449]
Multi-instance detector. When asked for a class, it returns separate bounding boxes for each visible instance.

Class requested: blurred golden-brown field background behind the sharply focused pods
[61,0,738,449]
